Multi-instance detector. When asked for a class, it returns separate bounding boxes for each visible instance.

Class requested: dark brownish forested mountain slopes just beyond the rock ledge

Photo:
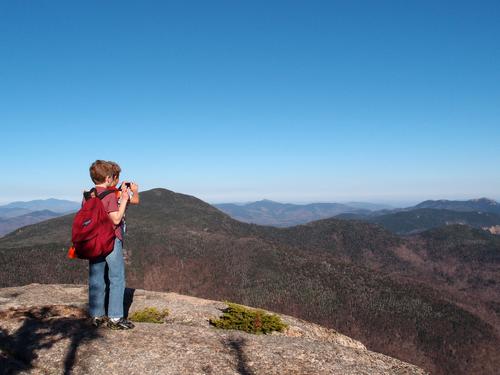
[0,189,500,374]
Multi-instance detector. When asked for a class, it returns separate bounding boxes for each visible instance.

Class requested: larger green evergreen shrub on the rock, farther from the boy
[209,301,287,334]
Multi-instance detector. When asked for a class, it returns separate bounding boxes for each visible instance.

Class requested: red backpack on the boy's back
[68,188,116,260]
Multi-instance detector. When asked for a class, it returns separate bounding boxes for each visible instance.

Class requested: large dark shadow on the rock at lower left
[0,305,100,374]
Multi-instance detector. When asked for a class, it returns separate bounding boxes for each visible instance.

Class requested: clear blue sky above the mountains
[0,0,500,203]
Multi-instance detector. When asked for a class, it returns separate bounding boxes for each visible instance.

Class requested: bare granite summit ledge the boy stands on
[0,284,425,375]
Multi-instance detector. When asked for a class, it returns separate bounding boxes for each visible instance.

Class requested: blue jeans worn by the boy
[89,238,125,318]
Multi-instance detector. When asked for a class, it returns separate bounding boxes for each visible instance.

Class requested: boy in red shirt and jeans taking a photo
[89,160,134,329]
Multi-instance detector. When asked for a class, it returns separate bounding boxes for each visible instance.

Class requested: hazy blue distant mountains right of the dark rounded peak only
[215,198,500,235]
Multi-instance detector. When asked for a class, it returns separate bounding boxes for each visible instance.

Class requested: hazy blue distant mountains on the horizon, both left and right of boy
[0,198,500,237]
